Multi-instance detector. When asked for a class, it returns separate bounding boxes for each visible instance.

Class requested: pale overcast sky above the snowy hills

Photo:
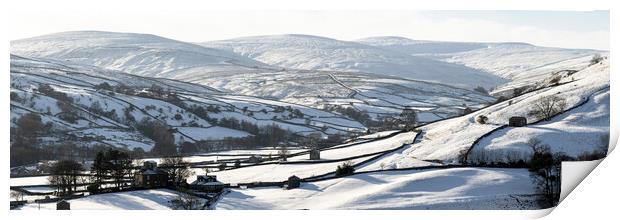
[9,8,609,50]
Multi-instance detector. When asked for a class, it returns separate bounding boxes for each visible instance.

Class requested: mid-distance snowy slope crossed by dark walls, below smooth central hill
[191,70,495,123]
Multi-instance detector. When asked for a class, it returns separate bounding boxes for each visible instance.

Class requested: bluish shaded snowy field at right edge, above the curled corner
[473,89,609,160]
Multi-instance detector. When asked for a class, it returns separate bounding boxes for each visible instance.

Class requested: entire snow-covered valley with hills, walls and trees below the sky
[10,31,610,210]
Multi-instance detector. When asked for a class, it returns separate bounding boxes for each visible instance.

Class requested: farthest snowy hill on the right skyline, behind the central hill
[358,37,608,96]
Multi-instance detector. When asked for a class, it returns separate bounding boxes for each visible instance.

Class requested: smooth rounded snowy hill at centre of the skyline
[201,35,505,88]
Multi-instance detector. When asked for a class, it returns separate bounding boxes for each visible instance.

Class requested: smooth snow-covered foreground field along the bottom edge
[216,168,534,209]
